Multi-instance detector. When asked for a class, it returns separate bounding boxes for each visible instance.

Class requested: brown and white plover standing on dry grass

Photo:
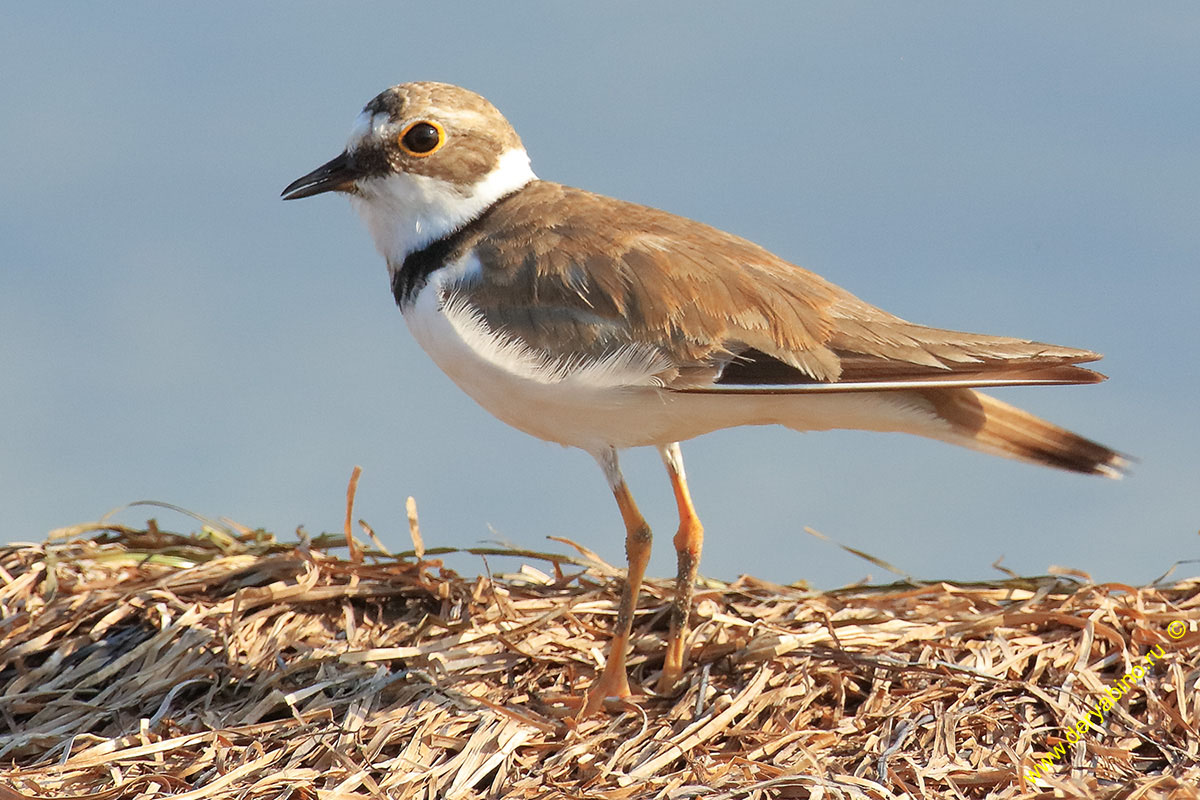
[283,83,1126,715]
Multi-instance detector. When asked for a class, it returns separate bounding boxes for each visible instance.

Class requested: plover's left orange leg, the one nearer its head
[580,449,650,718]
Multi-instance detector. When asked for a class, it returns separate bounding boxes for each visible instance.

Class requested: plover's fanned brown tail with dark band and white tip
[918,389,1129,477]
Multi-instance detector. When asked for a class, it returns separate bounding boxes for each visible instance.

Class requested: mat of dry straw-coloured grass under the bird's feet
[0,491,1200,800]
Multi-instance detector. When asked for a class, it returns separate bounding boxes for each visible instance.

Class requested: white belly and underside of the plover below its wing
[404,258,940,452]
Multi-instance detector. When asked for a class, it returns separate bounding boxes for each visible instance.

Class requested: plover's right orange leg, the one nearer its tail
[655,441,704,693]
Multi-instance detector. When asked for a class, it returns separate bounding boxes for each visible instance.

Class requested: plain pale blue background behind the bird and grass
[0,2,1200,587]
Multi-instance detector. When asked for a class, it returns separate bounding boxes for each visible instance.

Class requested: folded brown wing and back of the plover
[444,181,1103,391]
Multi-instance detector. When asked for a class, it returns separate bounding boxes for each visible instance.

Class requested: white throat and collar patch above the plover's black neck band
[350,148,538,271]
